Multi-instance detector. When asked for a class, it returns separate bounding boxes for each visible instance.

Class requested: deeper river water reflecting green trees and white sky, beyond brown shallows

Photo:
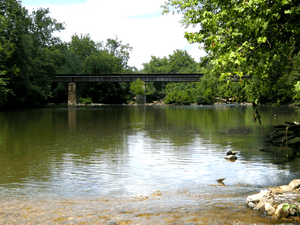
[0,106,299,197]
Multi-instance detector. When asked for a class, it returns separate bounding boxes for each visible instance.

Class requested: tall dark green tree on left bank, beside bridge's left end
[1,0,63,108]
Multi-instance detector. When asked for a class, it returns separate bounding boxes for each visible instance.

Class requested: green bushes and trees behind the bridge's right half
[142,50,245,105]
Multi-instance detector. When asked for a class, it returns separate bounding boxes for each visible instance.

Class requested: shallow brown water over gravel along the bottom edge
[0,187,269,225]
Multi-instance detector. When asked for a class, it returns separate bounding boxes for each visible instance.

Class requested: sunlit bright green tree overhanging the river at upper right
[163,0,300,103]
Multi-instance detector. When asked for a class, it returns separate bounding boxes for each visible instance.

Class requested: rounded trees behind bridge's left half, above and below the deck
[52,34,135,104]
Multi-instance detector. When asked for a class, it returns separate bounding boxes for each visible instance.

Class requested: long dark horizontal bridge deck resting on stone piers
[52,73,204,83]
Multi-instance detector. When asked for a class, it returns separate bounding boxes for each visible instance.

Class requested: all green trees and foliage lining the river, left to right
[0,0,300,110]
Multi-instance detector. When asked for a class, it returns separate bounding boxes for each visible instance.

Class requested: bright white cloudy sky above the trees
[22,0,205,69]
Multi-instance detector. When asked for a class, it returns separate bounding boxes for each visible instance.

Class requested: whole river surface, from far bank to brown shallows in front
[0,105,300,224]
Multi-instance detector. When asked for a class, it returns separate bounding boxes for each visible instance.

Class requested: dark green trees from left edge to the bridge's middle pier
[0,0,136,109]
